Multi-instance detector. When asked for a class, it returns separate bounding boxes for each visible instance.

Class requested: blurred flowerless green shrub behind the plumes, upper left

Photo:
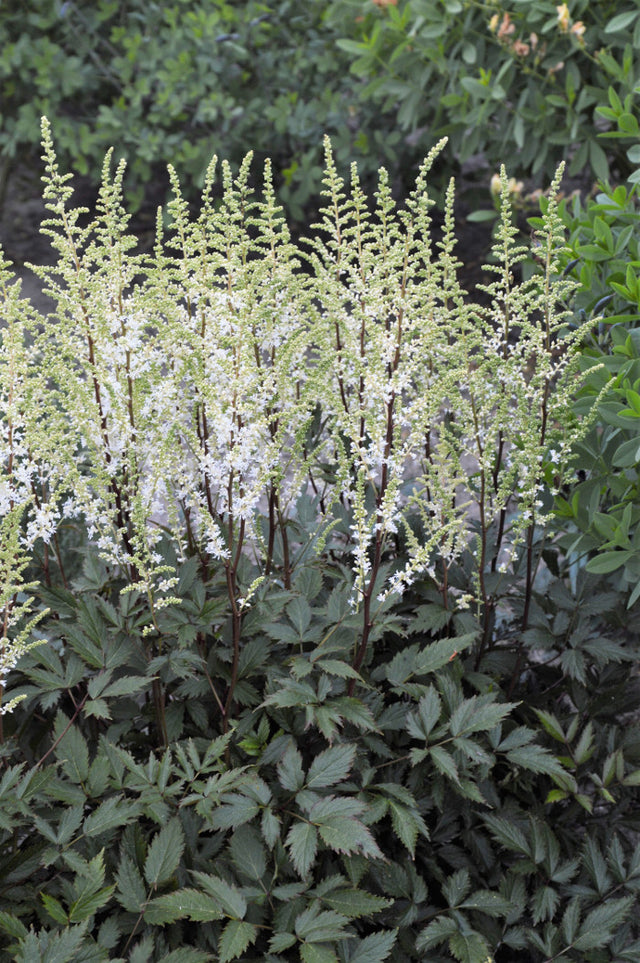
[0,0,408,219]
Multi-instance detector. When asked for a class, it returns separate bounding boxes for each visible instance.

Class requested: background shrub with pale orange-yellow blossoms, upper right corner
[330,0,640,180]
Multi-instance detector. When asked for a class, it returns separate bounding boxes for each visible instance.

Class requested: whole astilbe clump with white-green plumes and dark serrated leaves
[0,124,640,963]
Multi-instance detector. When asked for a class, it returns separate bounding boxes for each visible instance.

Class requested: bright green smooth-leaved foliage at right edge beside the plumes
[548,120,640,605]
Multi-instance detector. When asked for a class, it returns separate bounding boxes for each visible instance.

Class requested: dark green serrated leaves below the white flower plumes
[0,528,640,963]
